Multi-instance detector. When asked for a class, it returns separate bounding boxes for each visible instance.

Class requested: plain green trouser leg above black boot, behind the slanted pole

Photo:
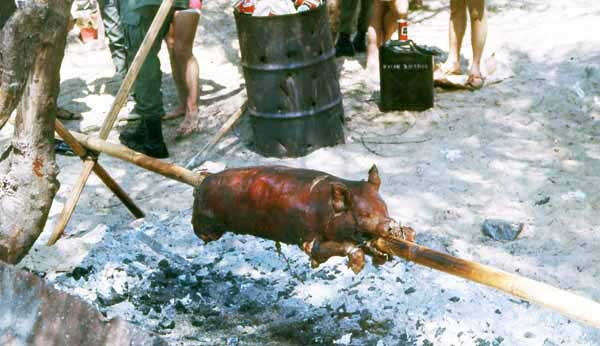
[121,1,170,121]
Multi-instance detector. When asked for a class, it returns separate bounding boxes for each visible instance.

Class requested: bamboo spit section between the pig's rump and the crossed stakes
[71,132,208,186]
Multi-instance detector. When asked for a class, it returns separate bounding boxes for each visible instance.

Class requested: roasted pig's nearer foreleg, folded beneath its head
[304,240,365,273]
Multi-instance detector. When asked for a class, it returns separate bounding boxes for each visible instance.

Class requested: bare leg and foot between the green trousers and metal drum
[168,11,200,136]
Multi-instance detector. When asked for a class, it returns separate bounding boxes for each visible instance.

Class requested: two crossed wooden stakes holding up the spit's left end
[48,0,174,245]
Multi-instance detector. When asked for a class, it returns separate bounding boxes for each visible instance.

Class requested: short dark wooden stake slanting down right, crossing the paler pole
[54,120,144,219]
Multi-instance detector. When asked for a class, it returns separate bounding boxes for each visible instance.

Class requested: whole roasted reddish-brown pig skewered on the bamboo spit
[192,166,414,272]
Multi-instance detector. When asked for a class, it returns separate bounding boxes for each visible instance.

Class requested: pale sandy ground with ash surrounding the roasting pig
[0,0,600,346]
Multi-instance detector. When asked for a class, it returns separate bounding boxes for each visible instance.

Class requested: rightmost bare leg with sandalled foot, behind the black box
[467,0,487,88]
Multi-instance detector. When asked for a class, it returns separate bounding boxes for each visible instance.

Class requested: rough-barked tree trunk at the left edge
[0,0,72,263]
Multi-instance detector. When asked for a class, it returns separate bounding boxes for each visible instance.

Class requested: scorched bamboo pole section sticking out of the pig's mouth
[374,238,600,328]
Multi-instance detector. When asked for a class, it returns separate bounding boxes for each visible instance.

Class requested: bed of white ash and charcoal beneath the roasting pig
[47,216,581,346]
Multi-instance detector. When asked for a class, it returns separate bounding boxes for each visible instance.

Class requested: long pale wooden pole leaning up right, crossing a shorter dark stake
[51,0,175,245]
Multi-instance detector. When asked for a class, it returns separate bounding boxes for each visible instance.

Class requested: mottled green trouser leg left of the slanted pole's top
[98,0,127,77]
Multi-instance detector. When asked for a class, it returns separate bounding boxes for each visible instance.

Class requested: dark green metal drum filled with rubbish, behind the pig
[234,4,344,157]
